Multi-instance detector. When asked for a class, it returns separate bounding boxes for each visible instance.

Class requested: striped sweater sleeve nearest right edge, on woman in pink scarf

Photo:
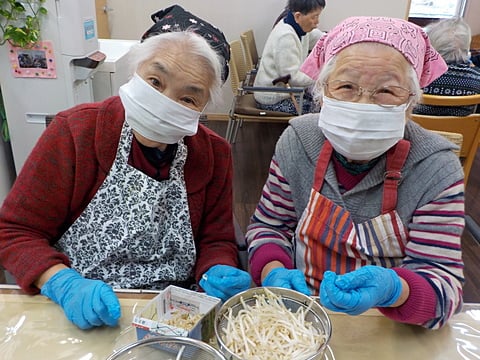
[382,180,465,329]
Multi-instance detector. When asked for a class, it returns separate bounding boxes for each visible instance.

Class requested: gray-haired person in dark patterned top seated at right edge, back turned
[414,18,480,116]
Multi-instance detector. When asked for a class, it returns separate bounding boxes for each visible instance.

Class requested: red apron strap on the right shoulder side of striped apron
[382,139,410,214]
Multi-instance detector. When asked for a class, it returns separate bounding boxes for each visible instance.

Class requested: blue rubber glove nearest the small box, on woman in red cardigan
[199,265,252,301]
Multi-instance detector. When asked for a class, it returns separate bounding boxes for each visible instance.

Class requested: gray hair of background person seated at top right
[425,17,472,64]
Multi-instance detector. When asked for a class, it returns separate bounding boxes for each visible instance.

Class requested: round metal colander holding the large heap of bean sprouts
[215,287,332,360]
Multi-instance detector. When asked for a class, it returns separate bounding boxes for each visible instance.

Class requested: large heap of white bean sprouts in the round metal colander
[221,289,326,360]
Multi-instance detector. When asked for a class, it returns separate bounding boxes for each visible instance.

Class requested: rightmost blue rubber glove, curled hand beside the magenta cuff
[320,265,402,315]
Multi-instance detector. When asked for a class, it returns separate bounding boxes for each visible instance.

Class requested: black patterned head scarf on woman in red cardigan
[142,5,230,82]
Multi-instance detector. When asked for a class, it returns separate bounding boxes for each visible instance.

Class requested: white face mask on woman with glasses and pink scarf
[318,96,407,160]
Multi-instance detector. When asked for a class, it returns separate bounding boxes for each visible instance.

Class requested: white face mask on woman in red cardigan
[118,73,201,144]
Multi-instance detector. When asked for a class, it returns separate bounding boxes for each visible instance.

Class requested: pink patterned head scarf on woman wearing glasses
[300,16,447,88]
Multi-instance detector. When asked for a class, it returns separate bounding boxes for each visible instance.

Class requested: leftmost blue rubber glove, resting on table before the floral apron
[41,269,121,330]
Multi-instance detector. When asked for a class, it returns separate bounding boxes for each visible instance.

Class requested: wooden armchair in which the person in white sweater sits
[225,40,305,143]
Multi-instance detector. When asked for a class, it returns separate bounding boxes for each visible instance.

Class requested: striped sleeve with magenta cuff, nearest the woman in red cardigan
[246,156,297,277]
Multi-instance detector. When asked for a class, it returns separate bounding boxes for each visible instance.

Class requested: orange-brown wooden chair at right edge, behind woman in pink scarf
[411,94,480,185]
